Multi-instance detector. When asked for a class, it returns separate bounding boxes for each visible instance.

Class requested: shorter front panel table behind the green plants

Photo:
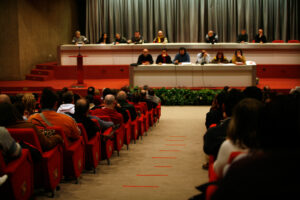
[129,62,256,87]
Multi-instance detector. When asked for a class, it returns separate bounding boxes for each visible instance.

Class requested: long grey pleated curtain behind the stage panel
[86,0,300,43]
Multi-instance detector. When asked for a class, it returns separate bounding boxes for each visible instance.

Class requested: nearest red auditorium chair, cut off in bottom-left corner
[0,149,34,200]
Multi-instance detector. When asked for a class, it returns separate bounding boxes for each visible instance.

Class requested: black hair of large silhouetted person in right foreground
[260,95,300,150]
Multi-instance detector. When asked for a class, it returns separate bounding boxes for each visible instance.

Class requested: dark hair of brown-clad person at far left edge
[0,103,20,127]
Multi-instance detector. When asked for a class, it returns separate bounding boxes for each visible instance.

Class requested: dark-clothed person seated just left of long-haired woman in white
[203,89,243,158]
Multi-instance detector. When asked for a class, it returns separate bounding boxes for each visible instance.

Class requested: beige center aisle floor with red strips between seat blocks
[37,106,209,200]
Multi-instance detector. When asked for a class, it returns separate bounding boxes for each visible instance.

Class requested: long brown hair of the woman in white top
[227,98,264,148]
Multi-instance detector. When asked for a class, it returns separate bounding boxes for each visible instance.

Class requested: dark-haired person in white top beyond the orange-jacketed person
[57,91,75,117]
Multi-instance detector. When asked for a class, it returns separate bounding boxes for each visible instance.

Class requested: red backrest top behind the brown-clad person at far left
[7,128,43,152]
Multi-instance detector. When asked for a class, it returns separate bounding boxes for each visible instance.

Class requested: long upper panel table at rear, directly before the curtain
[58,43,300,65]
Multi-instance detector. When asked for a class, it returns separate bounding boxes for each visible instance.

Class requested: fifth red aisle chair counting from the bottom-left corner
[92,119,114,165]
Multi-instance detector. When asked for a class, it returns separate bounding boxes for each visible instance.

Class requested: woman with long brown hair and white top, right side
[214,98,264,178]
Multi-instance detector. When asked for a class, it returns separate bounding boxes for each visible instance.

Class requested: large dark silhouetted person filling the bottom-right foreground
[212,95,300,200]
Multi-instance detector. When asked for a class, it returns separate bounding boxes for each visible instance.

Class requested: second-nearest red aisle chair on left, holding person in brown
[8,128,63,196]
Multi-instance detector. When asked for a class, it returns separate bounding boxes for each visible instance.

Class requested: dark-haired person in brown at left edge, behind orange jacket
[0,103,62,151]
